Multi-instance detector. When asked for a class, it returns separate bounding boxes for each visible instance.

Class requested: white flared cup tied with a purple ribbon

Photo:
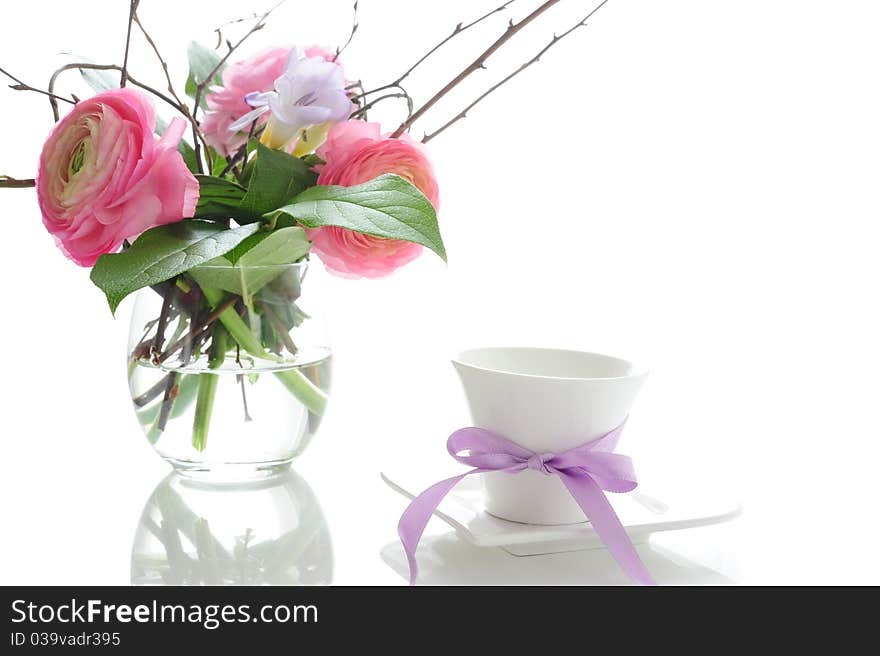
[452,348,647,524]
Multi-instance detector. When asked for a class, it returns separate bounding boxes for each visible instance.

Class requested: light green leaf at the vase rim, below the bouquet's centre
[190,227,312,298]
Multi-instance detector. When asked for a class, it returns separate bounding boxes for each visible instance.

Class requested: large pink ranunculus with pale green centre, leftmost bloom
[37,88,199,266]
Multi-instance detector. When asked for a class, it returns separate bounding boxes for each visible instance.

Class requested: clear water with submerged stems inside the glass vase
[129,347,331,474]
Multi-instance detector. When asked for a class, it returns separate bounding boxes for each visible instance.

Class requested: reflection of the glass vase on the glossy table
[131,471,333,585]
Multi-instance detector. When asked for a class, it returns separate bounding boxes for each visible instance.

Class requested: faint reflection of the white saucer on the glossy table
[382,532,733,585]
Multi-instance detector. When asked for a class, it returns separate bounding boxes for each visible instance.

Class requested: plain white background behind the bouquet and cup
[0,0,880,584]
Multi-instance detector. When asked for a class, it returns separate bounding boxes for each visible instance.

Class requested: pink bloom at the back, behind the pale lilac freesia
[201,46,339,157]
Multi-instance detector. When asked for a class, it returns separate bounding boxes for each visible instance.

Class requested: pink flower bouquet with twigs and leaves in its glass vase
[0,0,605,473]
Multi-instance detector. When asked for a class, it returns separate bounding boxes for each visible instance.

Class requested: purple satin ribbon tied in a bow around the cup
[397,422,655,585]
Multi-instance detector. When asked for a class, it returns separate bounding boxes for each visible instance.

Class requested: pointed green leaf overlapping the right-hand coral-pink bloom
[264,175,446,261]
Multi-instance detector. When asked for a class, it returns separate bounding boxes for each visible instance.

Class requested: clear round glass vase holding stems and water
[128,263,331,481]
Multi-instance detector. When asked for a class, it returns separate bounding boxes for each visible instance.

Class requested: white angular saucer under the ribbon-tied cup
[382,473,742,556]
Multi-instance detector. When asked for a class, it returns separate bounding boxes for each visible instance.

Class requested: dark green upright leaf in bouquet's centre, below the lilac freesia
[241,142,318,216]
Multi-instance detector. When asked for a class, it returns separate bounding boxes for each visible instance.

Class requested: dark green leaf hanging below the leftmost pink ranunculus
[91,221,260,313]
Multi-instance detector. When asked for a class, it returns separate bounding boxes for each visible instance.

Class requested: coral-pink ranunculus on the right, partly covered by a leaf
[308,120,440,278]
